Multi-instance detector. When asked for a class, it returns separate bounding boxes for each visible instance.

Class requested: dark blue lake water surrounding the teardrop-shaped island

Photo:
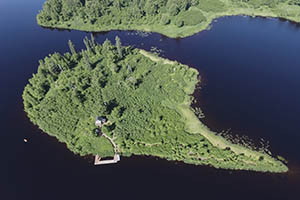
[0,0,300,200]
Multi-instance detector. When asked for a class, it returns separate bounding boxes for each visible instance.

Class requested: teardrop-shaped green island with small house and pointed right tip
[23,35,288,173]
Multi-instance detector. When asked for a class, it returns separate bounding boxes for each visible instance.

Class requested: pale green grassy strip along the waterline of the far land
[38,9,300,38]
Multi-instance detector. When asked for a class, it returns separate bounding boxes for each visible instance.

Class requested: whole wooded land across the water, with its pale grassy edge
[37,0,300,37]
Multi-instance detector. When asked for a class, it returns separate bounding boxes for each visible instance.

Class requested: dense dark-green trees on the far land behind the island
[38,0,209,26]
